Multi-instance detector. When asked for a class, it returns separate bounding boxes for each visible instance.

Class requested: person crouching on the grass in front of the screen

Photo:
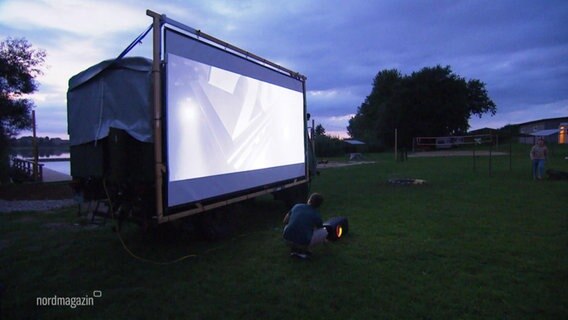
[283,193,327,259]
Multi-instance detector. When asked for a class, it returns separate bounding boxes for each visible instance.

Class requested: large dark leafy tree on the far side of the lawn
[347,66,496,147]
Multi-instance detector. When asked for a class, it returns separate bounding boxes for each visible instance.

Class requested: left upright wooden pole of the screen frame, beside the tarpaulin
[146,10,165,223]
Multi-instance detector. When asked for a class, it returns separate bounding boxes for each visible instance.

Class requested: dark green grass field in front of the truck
[0,146,568,319]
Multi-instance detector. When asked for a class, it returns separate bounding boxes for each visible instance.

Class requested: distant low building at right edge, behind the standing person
[518,117,568,144]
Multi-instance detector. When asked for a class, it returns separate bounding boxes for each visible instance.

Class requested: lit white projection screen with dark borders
[164,28,306,208]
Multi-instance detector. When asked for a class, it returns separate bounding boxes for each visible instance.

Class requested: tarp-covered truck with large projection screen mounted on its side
[67,10,316,231]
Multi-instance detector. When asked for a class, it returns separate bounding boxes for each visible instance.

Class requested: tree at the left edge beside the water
[0,38,46,183]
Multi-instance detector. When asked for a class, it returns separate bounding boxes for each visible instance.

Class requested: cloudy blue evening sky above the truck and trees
[0,0,568,138]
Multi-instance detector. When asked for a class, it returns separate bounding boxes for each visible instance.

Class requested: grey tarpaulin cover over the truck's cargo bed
[67,57,153,145]
